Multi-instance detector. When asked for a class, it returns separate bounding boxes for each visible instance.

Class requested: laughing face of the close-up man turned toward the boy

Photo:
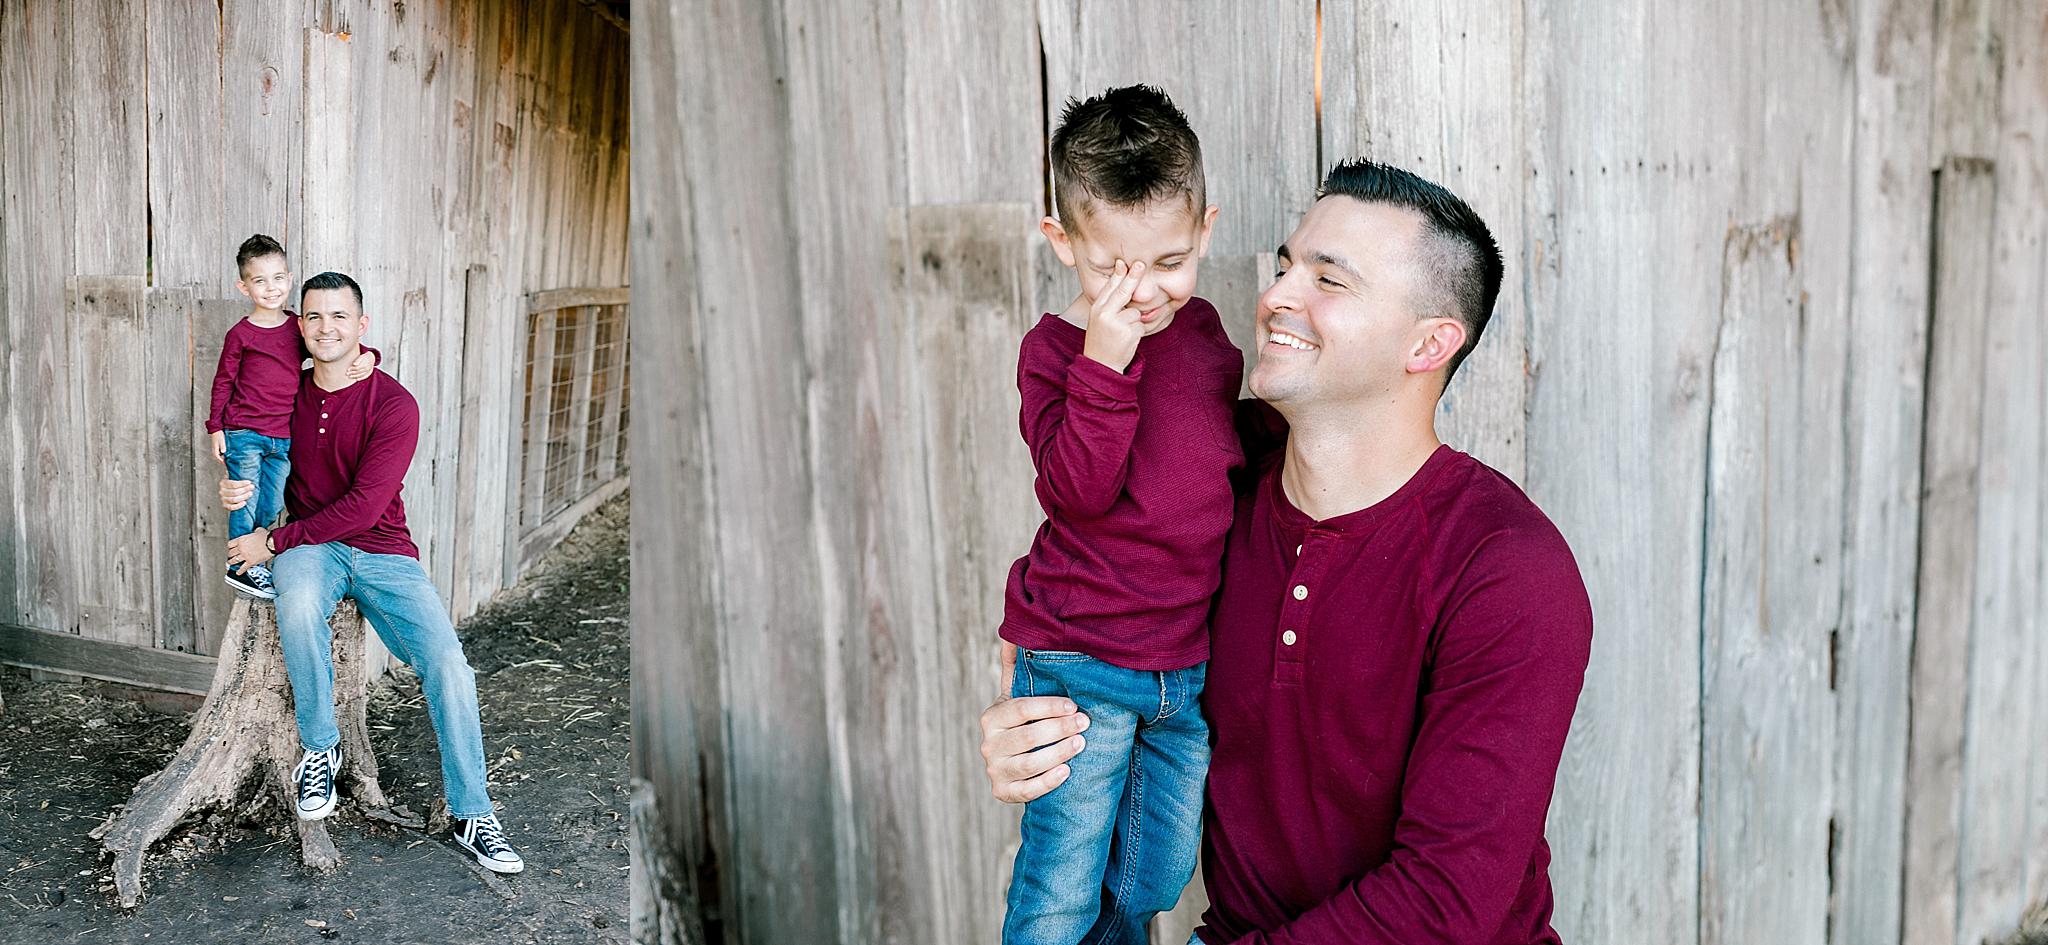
[1251,197,1423,410]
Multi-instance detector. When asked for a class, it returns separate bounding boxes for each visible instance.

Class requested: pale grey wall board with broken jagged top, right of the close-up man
[1700,217,1847,943]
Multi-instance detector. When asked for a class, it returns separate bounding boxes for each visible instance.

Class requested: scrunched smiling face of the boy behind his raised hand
[1038,199,1217,334]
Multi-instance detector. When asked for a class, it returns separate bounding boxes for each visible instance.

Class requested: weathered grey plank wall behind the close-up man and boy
[630,0,2048,945]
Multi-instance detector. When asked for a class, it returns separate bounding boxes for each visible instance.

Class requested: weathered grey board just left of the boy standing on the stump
[143,287,198,652]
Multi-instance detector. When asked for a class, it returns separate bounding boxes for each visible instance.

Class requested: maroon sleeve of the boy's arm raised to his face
[1018,336,1143,519]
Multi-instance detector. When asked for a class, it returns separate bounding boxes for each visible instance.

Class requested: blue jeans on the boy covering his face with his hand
[1004,648,1208,945]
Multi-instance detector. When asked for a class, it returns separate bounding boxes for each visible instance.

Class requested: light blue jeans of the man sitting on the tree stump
[270,541,492,818]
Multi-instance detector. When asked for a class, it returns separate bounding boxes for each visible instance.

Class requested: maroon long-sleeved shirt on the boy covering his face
[1001,299,1245,670]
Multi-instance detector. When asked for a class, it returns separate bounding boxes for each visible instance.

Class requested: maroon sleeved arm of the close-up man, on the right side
[1235,535,1593,945]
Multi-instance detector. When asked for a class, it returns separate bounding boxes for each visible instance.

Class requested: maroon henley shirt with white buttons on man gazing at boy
[1200,447,1593,945]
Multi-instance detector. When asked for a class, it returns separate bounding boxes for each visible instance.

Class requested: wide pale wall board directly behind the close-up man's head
[1321,0,1530,482]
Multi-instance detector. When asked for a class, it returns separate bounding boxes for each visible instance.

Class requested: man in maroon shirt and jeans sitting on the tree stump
[221,273,524,873]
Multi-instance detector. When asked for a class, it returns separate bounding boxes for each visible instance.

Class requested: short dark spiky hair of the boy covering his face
[1053,86,1206,230]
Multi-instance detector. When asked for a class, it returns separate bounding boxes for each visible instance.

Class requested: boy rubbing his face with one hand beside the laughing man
[1001,86,1243,945]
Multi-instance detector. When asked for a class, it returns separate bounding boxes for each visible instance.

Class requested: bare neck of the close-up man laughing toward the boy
[1280,393,1442,521]
